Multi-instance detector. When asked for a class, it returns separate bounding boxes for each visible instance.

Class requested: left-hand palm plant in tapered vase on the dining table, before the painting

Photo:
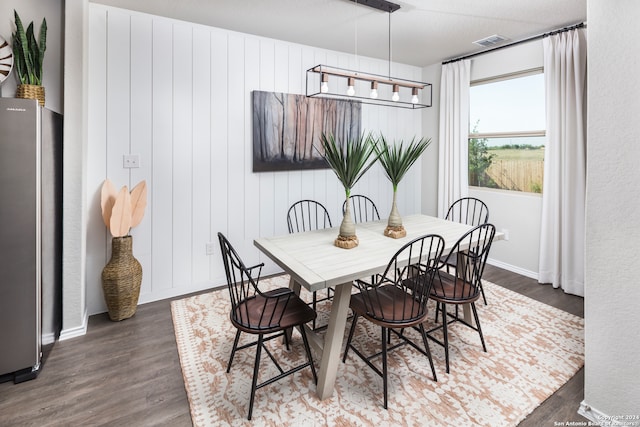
[320,133,384,249]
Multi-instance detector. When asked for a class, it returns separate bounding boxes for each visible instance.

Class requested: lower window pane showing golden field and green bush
[469,137,544,193]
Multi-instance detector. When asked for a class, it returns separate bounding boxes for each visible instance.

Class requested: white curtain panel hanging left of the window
[438,60,471,218]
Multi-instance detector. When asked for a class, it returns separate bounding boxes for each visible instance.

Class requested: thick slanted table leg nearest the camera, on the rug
[317,282,351,400]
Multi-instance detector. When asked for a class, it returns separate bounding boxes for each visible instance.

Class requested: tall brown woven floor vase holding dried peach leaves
[102,236,142,322]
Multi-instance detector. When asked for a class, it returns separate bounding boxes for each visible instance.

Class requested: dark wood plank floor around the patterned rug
[0,266,587,427]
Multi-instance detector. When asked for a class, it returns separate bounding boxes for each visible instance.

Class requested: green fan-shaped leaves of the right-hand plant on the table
[374,135,431,192]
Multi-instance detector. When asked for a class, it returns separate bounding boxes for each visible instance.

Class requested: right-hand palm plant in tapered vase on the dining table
[374,135,431,239]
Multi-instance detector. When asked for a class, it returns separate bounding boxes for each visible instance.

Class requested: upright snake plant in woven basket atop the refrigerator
[12,10,47,107]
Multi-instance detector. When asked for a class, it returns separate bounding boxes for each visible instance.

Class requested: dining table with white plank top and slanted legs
[254,214,503,400]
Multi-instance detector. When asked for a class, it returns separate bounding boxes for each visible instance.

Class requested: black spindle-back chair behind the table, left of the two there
[287,199,333,330]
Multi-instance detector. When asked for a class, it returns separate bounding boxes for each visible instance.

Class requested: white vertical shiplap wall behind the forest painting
[87,3,424,314]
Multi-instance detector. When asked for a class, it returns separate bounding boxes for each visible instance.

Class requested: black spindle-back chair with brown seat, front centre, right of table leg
[342,235,444,409]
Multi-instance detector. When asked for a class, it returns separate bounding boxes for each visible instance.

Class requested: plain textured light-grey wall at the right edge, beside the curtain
[581,0,640,420]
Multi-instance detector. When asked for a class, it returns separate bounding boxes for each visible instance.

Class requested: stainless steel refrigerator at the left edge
[0,98,62,382]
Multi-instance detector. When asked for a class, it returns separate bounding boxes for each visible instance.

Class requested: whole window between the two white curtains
[469,69,546,193]
